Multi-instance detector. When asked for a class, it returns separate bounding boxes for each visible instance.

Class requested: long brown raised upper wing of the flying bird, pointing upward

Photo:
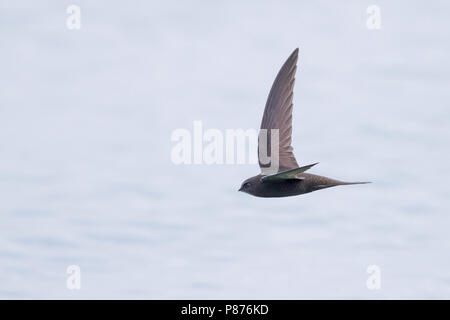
[258,48,298,173]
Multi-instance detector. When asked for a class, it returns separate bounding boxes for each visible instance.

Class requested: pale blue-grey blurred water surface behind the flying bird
[0,0,450,299]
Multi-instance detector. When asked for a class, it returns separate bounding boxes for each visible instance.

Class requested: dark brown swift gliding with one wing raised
[239,48,369,198]
